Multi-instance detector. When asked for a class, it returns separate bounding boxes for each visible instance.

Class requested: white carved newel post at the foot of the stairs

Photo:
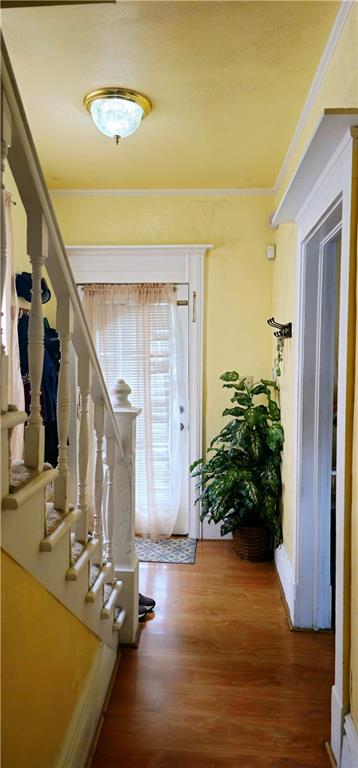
[112,379,141,643]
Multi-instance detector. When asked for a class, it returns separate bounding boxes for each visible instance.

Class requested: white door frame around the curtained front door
[66,244,213,538]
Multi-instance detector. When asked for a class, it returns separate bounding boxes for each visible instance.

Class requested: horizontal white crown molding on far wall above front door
[50,187,274,197]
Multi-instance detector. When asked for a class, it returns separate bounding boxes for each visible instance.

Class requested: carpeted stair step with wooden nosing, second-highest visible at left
[2,462,58,509]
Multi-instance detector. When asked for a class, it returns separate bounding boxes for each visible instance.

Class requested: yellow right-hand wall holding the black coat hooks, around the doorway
[273,3,358,728]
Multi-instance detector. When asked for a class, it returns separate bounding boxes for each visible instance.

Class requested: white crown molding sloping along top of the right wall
[273,0,355,194]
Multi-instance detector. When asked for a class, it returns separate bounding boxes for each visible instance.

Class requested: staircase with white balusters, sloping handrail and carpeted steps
[0,40,138,650]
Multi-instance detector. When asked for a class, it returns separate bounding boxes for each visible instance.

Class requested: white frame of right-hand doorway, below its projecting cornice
[292,132,352,766]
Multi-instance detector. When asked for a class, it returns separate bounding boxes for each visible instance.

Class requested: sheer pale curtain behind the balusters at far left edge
[1,191,25,459]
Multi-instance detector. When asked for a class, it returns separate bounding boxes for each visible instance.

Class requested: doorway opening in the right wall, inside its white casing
[298,200,342,629]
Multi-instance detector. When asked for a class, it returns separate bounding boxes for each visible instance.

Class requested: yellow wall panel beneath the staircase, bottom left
[2,553,100,768]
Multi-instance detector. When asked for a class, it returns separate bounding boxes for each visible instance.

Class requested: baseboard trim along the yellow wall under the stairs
[54,643,117,768]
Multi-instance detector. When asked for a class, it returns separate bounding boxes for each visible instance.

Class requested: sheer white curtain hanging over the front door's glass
[83,283,181,537]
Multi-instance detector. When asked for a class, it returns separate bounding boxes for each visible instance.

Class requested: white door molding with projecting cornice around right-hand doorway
[273,117,358,767]
